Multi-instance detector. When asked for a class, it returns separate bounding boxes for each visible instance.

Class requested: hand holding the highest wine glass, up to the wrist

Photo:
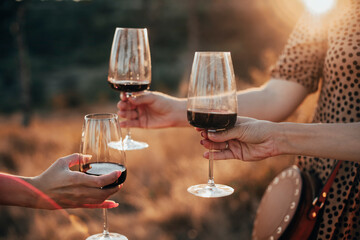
[117,91,189,128]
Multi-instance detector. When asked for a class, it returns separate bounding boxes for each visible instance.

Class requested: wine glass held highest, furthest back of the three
[108,28,151,150]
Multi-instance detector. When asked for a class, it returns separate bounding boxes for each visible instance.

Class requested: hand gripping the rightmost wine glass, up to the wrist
[201,117,279,161]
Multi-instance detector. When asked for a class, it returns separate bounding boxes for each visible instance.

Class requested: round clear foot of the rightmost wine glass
[187,184,234,198]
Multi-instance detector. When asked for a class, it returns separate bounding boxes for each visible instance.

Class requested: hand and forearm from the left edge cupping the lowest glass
[0,153,121,210]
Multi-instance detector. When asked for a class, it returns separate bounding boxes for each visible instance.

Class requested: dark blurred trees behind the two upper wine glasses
[0,0,298,116]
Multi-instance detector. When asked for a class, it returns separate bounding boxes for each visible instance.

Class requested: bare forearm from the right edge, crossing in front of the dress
[274,122,360,161]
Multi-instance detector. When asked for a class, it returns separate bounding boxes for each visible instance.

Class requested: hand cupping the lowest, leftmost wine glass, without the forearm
[26,154,122,209]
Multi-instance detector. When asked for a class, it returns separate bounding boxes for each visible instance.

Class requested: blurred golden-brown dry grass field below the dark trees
[0,89,316,240]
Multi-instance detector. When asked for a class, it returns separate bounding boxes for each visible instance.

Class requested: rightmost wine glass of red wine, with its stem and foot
[187,52,237,198]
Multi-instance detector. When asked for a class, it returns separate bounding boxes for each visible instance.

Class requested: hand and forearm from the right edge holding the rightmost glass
[201,117,360,162]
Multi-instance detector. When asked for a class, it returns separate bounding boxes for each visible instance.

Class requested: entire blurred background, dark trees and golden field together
[0,0,316,240]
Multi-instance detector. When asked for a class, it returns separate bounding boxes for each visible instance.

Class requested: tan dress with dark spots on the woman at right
[271,0,360,240]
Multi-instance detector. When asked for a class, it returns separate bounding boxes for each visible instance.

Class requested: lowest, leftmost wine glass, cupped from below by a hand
[79,113,127,240]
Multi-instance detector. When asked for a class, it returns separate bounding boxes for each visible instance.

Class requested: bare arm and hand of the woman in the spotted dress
[117,79,308,128]
